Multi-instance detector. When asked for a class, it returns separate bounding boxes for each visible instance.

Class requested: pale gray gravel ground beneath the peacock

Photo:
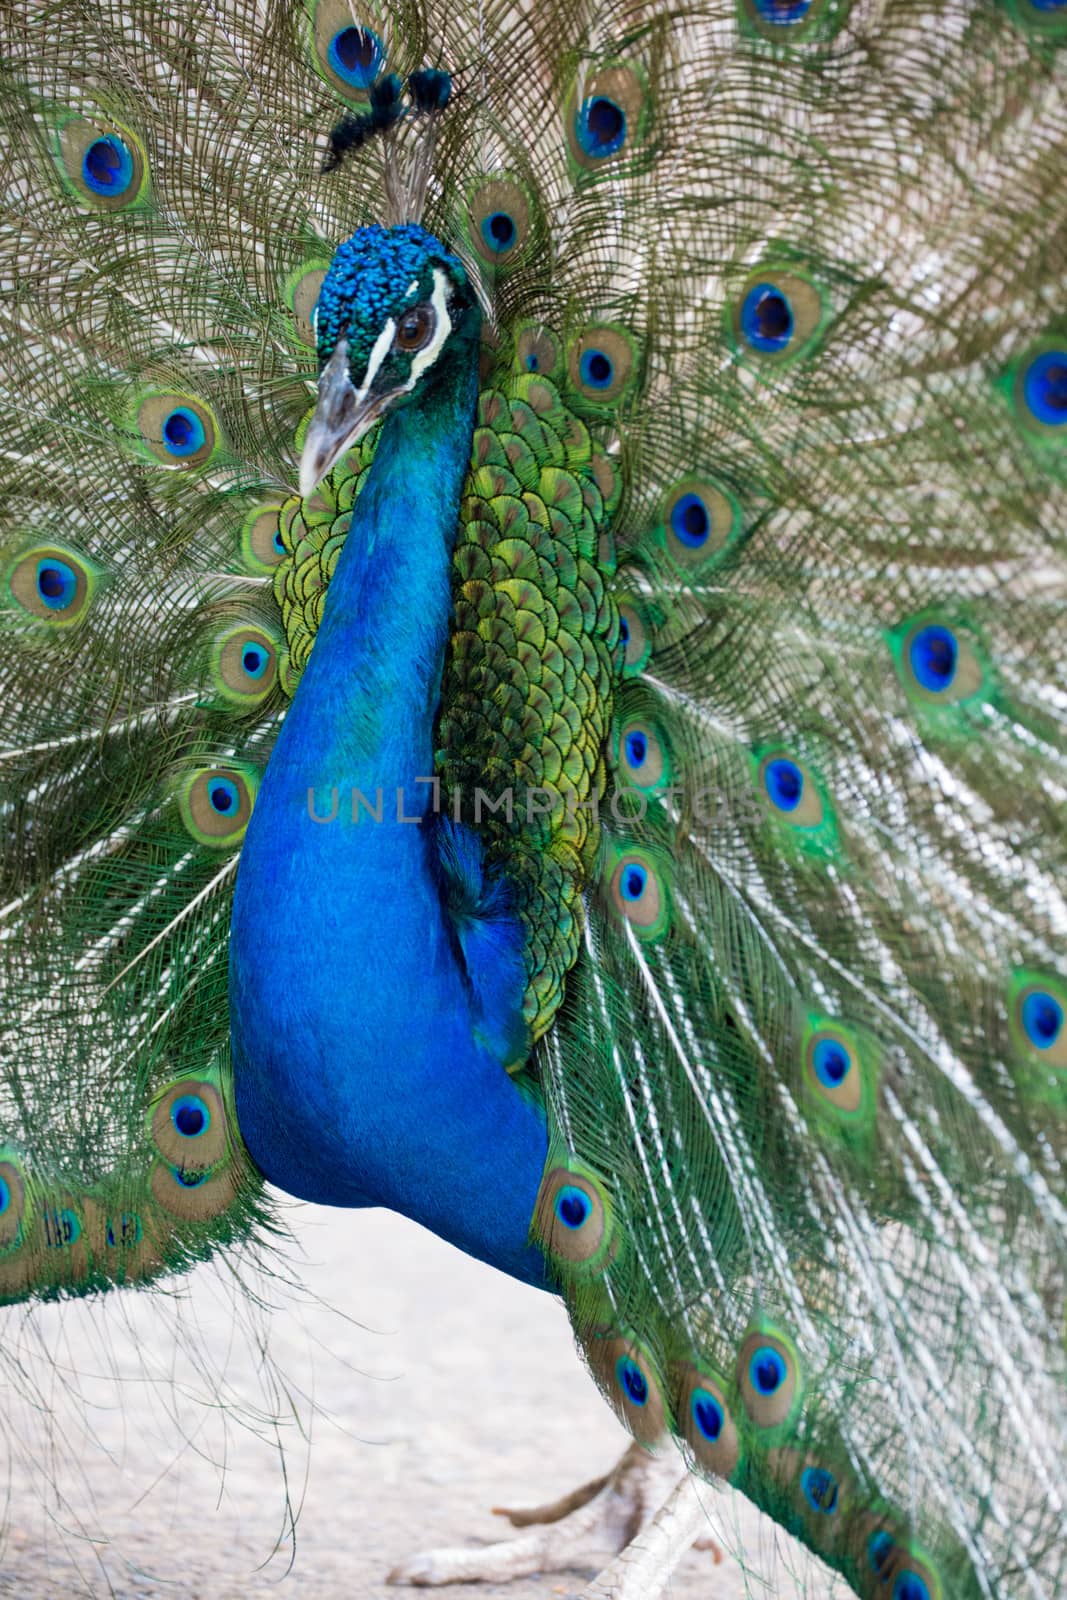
[0,1206,845,1600]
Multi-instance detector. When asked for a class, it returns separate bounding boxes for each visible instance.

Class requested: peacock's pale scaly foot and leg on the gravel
[387,1445,721,1600]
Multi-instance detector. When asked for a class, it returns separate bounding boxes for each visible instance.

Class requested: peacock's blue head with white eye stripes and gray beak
[301,222,478,496]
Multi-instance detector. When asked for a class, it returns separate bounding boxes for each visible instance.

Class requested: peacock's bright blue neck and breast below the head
[230,334,547,1282]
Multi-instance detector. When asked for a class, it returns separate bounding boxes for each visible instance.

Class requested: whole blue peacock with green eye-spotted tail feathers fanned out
[0,0,1067,1600]
